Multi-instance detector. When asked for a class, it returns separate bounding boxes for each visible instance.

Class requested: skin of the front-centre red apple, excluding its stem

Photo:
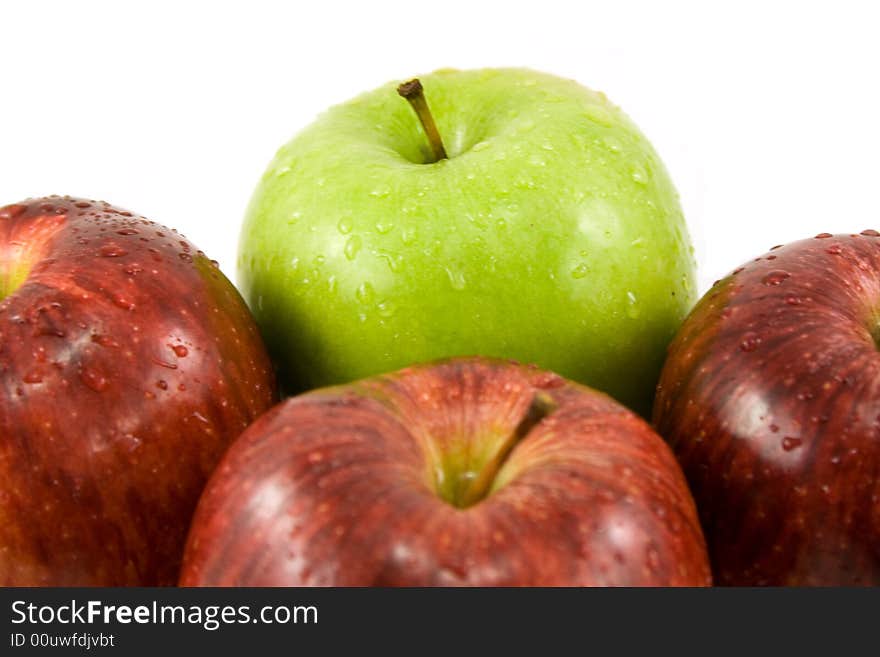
[181,358,710,586]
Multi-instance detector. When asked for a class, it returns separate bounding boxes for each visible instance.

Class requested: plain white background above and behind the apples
[0,0,880,290]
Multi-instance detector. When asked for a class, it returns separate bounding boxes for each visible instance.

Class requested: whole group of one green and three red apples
[0,69,880,586]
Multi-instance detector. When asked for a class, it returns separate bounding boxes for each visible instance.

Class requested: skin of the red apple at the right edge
[654,231,880,586]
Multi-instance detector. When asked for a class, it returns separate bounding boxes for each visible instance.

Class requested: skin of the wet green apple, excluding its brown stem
[238,69,696,414]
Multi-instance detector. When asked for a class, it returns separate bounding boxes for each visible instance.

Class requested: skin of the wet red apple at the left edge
[0,197,275,586]
